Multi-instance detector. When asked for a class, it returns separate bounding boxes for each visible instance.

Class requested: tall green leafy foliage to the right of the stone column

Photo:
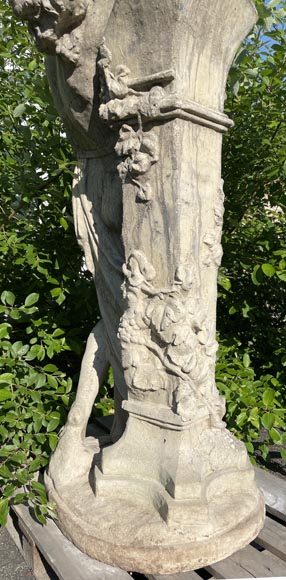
[217,0,286,459]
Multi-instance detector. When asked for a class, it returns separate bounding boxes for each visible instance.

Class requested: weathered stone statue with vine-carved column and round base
[11,0,264,573]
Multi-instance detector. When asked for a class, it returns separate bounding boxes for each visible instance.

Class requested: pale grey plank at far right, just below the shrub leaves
[255,467,286,521]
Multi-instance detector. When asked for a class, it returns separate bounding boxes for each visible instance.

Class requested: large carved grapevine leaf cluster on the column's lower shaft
[119,250,224,426]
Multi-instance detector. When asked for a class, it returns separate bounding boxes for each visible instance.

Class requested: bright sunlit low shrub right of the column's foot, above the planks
[216,340,286,460]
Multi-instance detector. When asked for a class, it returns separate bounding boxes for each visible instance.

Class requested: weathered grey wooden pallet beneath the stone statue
[7,469,286,580]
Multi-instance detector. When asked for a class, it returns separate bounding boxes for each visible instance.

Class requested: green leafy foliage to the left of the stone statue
[0,2,100,525]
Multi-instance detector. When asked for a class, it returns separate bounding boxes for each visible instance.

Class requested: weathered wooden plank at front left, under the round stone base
[13,505,131,580]
